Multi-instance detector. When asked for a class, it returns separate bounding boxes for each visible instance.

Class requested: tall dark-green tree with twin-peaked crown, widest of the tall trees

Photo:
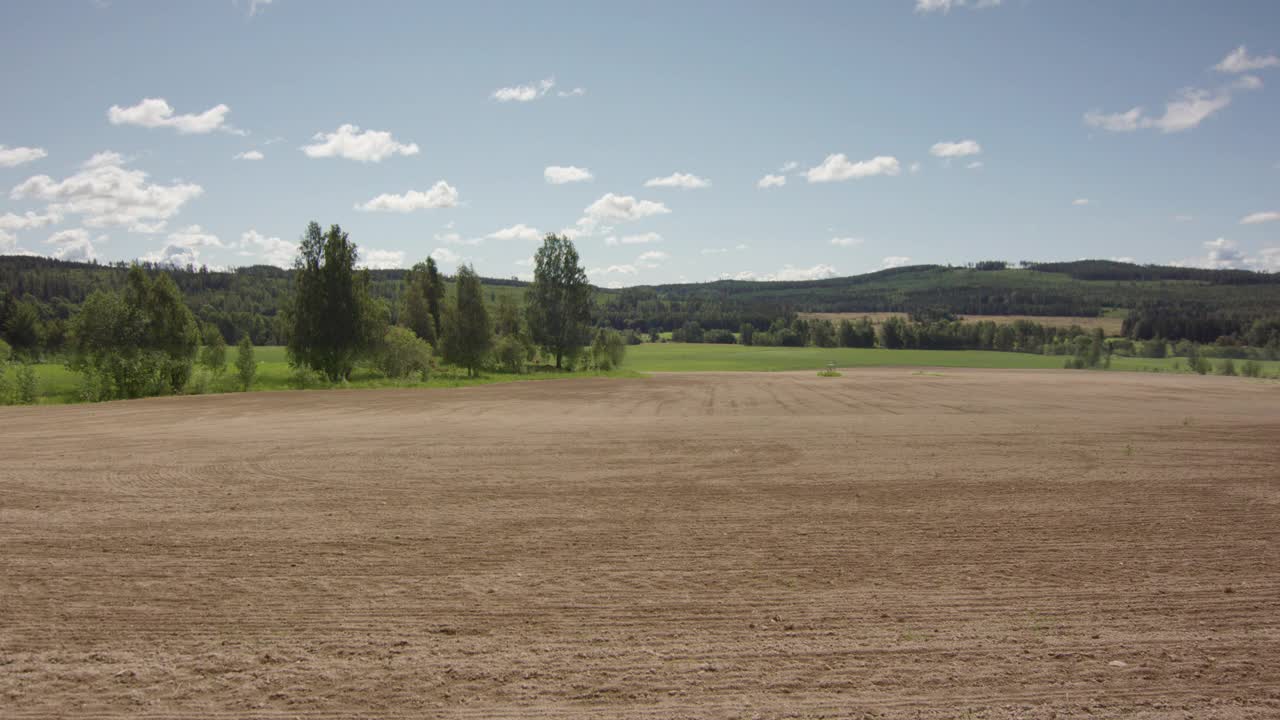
[284,223,387,382]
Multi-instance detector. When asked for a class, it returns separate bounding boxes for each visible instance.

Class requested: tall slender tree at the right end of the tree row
[526,233,591,369]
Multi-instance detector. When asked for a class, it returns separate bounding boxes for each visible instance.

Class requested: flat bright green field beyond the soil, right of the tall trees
[622,342,1280,377]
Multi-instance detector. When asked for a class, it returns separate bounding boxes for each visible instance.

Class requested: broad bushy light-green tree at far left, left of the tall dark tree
[68,266,198,400]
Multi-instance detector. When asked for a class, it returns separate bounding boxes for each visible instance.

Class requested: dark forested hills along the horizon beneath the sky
[0,256,1280,343]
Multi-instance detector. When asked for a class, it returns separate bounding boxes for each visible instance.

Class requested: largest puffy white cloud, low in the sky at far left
[9,152,204,232]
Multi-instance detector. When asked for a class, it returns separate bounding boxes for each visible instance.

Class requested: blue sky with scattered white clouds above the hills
[0,0,1280,287]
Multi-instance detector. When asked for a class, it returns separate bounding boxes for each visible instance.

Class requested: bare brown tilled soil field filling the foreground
[0,369,1280,719]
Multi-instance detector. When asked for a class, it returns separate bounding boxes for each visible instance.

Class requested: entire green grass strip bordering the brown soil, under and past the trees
[15,342,1280,404]
